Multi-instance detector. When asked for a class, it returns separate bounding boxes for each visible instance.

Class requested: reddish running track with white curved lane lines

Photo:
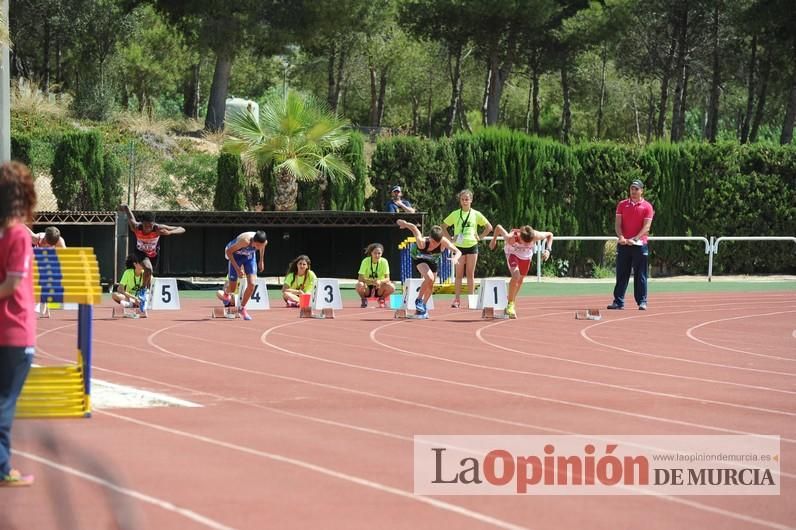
[0,292,796,530]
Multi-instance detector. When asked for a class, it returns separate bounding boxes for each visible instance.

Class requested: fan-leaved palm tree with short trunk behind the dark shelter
[224,90,354,211]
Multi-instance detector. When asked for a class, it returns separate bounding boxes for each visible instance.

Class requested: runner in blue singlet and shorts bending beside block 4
[216,230,268,320]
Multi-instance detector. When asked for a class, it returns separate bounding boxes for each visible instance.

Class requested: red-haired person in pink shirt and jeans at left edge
[0,162,36,487]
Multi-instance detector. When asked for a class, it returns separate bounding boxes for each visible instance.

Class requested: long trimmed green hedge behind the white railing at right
[368,129,796,275]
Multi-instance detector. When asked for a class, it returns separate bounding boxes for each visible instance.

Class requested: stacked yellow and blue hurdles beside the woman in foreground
[16,247,102,418]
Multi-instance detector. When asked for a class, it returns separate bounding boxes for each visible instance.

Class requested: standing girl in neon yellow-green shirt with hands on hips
[442,190,492,307]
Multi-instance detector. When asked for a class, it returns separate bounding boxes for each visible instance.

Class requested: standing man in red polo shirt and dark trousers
[608,180,655,311]
